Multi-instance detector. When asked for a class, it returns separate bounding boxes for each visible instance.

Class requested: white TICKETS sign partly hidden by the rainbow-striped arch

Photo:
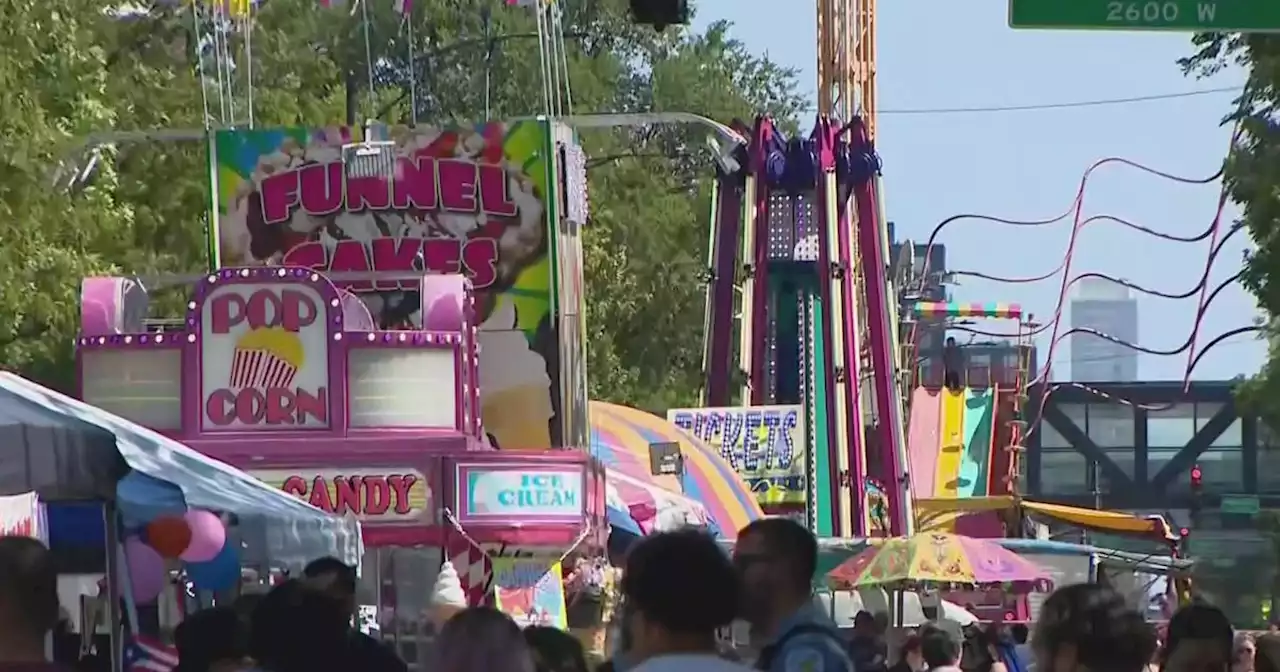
[667,406,806,504]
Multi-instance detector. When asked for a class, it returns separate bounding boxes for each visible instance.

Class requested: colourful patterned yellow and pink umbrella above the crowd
[827,532,1053,591]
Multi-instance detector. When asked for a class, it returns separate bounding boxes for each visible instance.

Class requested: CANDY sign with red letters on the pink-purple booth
[250,468,431,524]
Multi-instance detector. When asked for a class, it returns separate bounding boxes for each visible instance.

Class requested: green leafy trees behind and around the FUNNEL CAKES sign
[0,0,803,411]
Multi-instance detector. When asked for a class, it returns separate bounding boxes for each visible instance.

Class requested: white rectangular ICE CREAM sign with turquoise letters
[457,465,585,522]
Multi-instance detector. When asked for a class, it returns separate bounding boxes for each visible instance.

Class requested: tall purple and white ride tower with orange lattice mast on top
[705,0,913,536]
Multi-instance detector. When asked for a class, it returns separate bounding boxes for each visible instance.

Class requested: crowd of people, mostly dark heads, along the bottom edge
[0,518,1259,672]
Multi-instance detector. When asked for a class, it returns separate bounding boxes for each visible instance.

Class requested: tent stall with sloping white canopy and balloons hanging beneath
[0,372,362,669]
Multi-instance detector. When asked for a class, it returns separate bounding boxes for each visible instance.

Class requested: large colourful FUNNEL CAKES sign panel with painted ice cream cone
[211,120,563,451]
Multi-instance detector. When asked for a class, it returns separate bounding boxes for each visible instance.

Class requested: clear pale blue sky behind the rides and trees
[695,0,1265,380]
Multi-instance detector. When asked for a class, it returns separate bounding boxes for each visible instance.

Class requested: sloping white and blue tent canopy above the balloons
[0,372,362,566]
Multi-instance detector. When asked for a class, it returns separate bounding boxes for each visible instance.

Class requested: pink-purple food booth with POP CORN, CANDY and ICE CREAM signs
[79,266,604,662]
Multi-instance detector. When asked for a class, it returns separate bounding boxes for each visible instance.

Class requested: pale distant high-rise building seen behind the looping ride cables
[1068,278,1138,383]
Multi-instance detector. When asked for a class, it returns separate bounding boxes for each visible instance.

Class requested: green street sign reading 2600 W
[1009,0,1280,32]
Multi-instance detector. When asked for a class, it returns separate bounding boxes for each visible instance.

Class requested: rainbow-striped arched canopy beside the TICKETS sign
[590,402,764,539]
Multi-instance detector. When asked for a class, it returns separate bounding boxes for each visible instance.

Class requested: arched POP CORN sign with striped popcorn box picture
[200,282,329,431]
